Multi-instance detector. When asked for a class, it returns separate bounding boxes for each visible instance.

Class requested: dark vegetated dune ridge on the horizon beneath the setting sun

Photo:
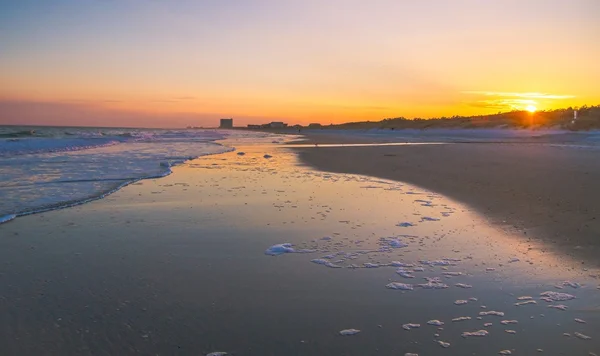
[322,105,600,130]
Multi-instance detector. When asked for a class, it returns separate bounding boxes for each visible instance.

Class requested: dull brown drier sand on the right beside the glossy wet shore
[297,136,600,262]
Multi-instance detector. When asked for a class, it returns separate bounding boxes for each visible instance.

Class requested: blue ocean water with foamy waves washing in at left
[0,126,282,223]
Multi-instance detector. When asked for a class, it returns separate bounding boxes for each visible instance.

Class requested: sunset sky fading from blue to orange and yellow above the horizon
[0,0,600,127]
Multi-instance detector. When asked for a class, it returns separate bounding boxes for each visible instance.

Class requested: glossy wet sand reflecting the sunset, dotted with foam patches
[0,138,600,355]
